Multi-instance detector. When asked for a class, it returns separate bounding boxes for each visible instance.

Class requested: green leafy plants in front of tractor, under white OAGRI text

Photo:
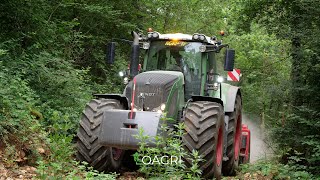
[133,118,203,179]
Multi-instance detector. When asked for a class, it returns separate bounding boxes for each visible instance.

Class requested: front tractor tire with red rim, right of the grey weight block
[182,101,225,179]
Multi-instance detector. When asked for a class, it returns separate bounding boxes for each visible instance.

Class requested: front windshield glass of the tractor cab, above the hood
[145,40,202,100]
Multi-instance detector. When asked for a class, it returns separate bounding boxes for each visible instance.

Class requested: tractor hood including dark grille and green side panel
[125,71,184,114]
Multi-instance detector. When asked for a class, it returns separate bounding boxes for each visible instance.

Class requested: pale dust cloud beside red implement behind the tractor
[242,114,272,163]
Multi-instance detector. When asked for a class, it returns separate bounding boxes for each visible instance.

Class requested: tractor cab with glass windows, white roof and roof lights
[142,32,233,102]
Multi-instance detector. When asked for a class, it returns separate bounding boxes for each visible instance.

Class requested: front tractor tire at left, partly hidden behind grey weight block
[76,99,124,171]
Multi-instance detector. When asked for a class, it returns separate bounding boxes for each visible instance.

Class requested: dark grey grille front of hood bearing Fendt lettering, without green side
[126,72,178,111]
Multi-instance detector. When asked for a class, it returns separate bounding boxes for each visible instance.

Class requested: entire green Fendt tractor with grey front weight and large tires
[77,30,250,179]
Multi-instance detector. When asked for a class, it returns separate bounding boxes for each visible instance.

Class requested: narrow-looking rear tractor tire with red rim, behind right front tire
[222,95,242,176]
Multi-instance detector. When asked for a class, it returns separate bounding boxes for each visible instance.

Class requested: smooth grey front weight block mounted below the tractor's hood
[98,109,162,149]
